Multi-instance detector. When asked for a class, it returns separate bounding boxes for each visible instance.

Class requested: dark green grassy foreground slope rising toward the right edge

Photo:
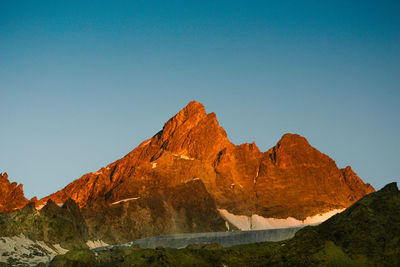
[50,183,400,266]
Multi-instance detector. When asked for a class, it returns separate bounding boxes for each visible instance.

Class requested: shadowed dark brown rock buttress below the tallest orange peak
[82,180,226,244]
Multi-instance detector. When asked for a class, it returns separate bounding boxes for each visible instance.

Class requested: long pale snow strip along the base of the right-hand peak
[218,209,344,230]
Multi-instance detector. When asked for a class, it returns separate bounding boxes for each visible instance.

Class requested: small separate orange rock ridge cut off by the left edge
[0,173,28,213]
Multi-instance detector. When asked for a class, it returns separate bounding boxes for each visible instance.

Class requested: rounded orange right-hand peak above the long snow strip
[252,134,374,219]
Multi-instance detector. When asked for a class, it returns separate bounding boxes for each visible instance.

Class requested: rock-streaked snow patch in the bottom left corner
[0,234,68,266]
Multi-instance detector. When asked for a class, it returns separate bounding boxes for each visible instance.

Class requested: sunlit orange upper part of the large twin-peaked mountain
[39,102,374,219]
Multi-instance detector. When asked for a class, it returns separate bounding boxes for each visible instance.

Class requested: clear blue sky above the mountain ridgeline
[0,0,400,198]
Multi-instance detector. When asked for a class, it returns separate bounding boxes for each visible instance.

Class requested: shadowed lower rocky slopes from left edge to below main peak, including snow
[0,180,228,266]
